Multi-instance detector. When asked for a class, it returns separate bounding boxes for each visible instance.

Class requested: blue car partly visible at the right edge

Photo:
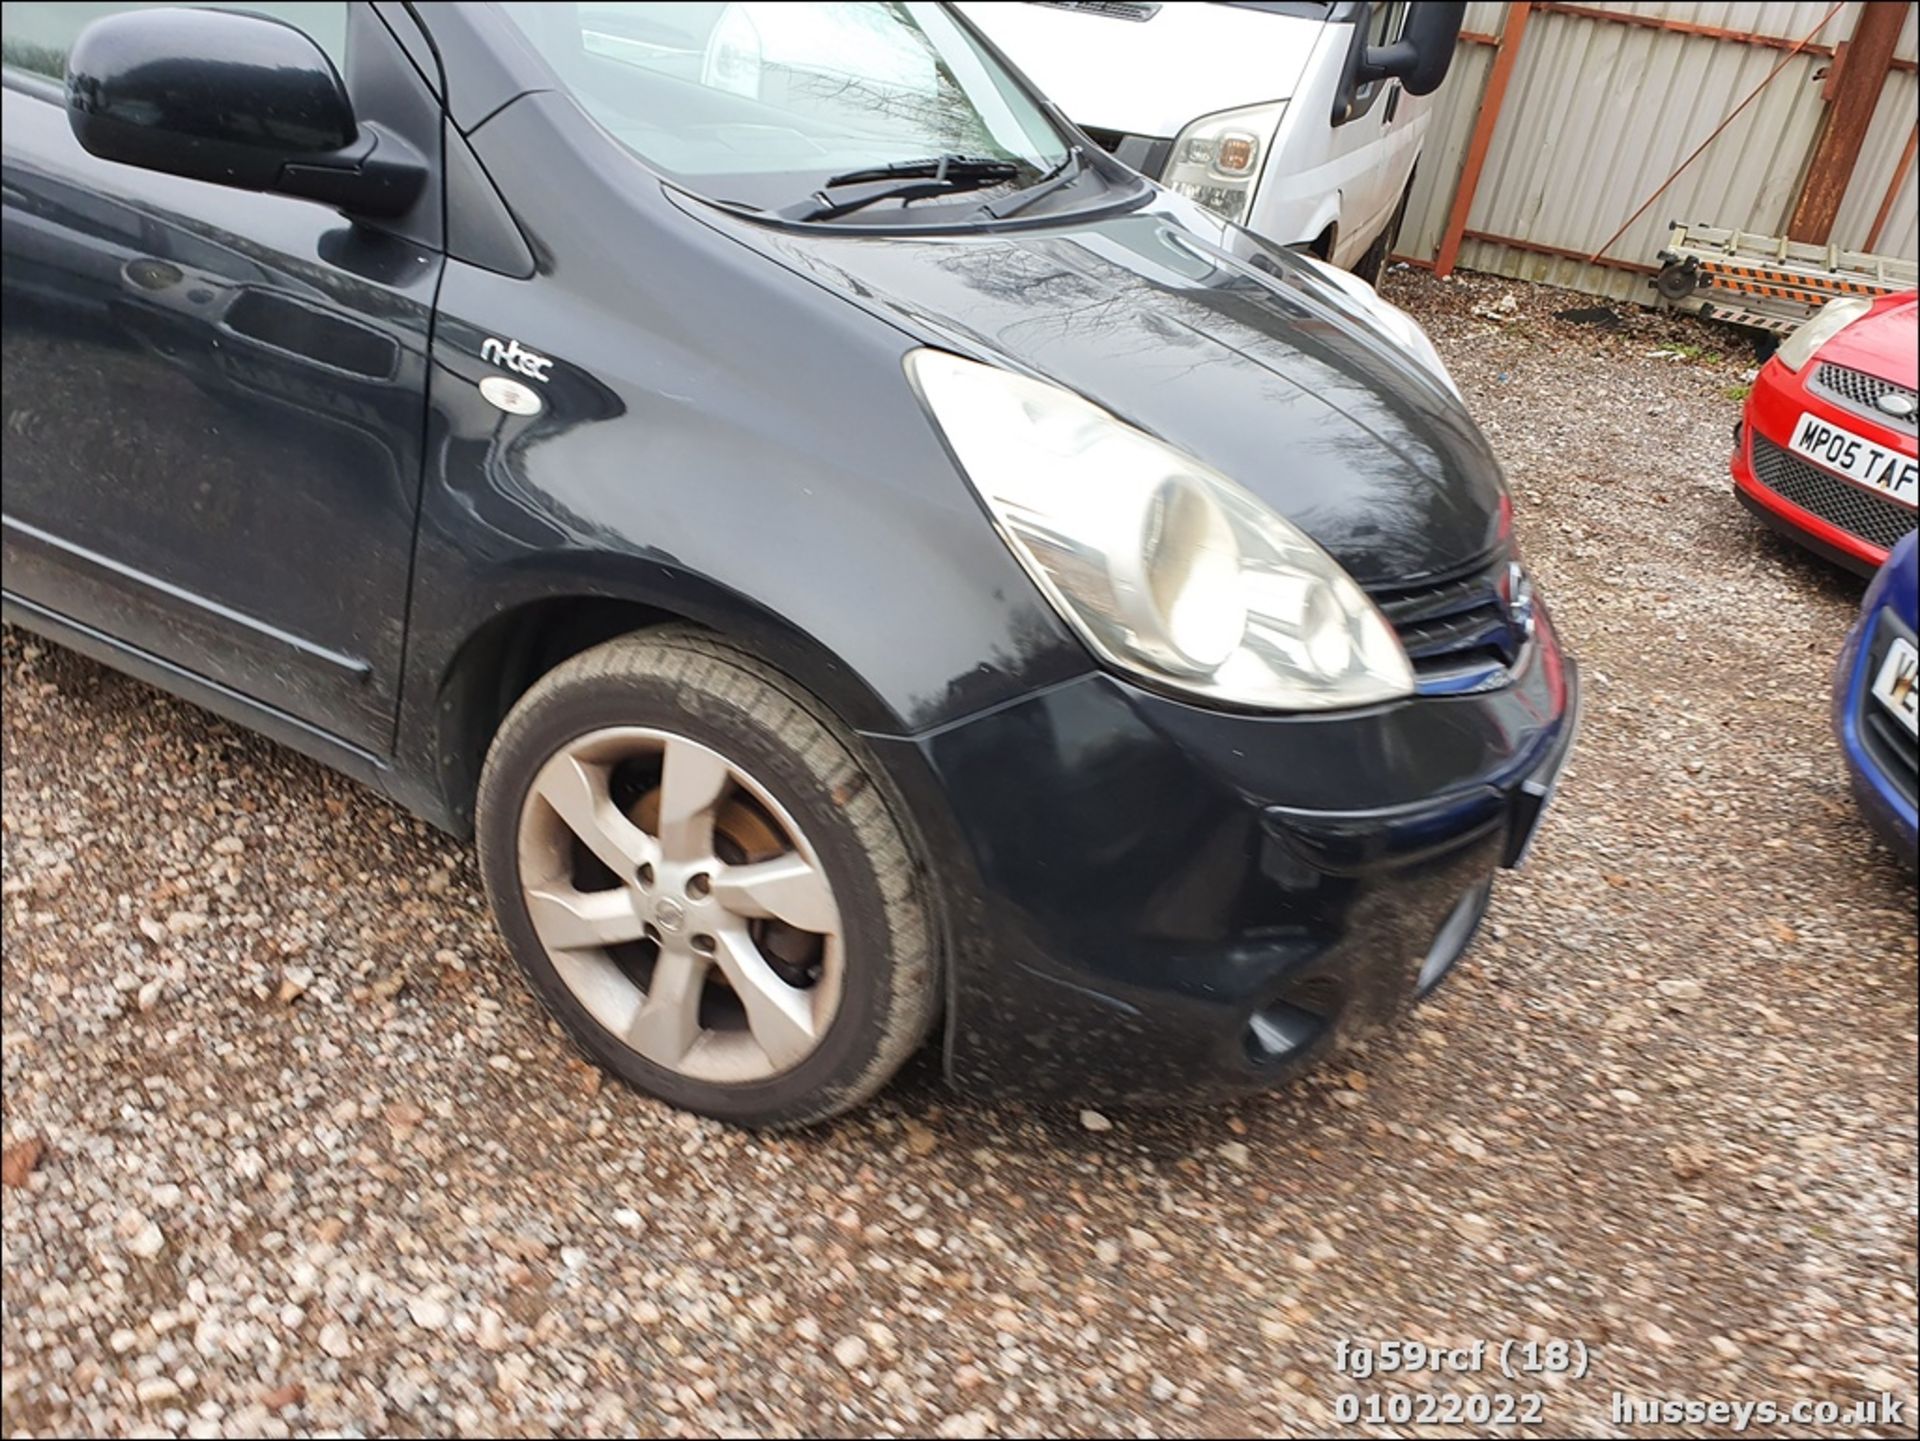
[1834,532,1920,865]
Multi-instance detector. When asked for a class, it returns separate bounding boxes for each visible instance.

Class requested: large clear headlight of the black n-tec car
[906,349,1413,710]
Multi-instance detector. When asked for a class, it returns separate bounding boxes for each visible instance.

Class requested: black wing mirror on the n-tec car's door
[67,10,426,217]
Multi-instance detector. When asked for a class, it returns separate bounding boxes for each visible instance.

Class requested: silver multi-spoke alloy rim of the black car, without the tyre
[518,725,845,1084]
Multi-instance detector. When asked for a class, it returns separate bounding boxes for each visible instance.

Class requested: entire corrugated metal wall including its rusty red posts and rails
[1396,0,1920,299]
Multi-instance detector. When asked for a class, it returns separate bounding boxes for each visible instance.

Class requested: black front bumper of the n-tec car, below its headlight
[879,608,1578,1103]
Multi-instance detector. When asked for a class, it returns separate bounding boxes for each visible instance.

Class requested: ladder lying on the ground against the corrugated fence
[1649,221,1920,334]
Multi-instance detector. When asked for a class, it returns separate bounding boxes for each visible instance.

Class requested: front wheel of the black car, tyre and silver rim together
[476,629,939,1126]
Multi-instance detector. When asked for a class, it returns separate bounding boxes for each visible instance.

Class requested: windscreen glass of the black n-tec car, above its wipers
[501,0,1069,222]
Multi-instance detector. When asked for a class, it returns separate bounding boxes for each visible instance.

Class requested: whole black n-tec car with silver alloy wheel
[4,0,1576,1124]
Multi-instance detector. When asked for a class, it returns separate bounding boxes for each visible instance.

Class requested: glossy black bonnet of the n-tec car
[684,194,1507,587]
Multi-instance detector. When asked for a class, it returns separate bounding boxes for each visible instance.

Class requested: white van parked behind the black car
[960,0,1467,280]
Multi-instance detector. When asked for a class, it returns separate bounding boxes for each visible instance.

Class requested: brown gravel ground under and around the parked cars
[0,269,1920,1435]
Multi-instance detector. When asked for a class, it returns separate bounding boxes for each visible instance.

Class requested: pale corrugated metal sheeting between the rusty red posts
[1396,0,1920,299]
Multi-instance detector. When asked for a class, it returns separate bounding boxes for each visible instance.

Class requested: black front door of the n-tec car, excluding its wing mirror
[0,0,444,754]
